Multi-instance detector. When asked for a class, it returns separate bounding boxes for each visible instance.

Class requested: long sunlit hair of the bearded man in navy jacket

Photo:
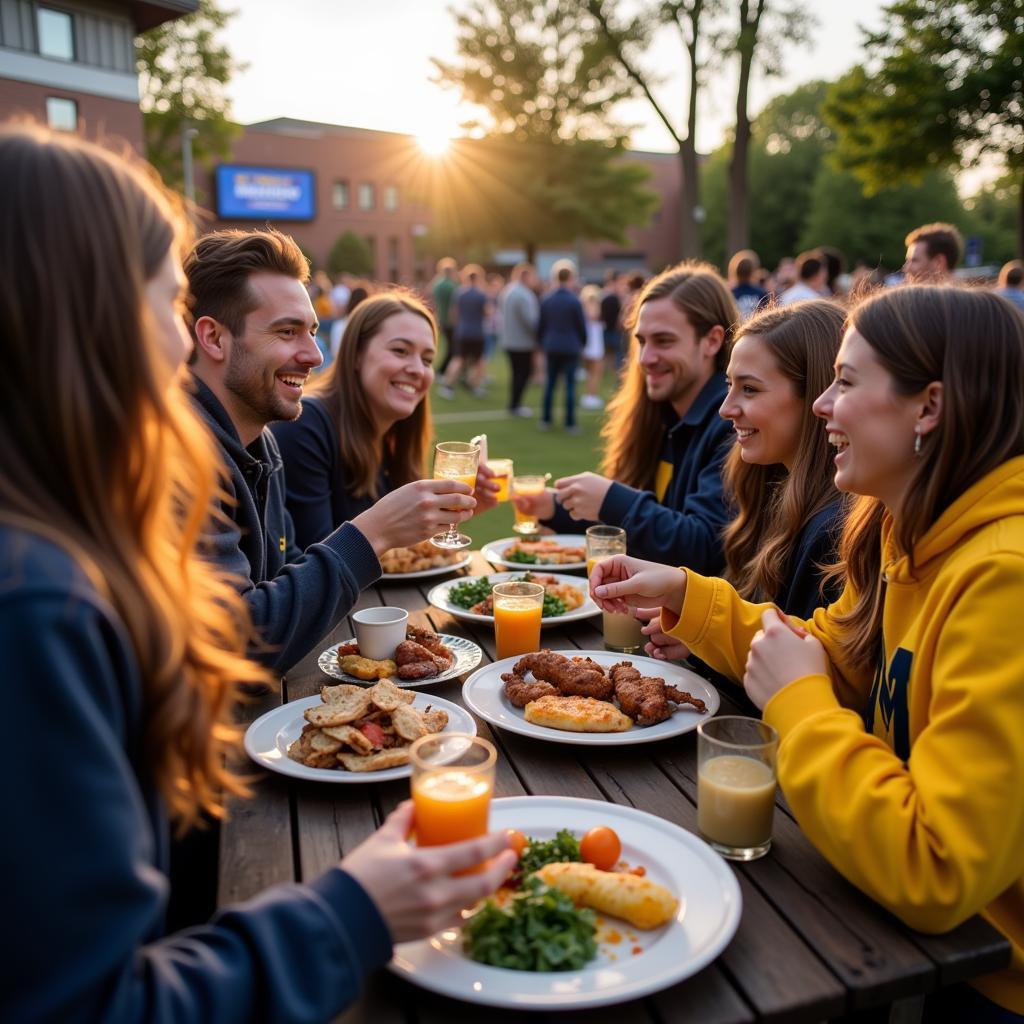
[601,260,739,490]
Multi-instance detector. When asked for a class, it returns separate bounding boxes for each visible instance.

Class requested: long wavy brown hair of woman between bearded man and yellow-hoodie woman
[722,299,846,601]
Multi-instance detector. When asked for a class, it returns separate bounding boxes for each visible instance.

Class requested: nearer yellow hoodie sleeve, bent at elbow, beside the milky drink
[765,556,1024,932]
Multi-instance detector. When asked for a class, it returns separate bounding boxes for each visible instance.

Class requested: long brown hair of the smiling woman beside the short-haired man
[309,289,437,500]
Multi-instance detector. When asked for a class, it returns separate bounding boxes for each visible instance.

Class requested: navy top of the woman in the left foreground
[0,525,391,1024]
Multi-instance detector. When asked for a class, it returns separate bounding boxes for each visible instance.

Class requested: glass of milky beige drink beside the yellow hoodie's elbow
[697,715,778,860]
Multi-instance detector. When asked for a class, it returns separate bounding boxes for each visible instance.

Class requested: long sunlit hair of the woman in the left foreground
[0,125,266,827]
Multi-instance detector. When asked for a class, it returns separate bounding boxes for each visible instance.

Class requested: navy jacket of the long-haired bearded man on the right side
[545,374,733,575]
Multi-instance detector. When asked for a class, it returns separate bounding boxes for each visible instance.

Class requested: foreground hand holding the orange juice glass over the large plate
[341,800,518,942]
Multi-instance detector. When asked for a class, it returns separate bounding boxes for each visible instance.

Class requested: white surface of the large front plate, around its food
[389,797,742,1010]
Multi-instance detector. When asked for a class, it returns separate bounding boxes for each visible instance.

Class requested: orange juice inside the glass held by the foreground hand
[413,768,493,846]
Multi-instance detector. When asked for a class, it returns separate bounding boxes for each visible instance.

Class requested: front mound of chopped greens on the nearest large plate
[463,876,597,972]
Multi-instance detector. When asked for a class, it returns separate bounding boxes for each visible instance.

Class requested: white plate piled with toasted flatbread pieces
[245,679,476,782]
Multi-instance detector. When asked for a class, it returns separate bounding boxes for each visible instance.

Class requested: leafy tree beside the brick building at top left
[135,0,245,190]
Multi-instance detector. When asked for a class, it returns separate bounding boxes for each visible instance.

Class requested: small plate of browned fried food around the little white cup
[316,626,483,687]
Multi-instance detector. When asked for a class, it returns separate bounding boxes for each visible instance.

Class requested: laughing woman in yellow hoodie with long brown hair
[591,287,1024,1021]
